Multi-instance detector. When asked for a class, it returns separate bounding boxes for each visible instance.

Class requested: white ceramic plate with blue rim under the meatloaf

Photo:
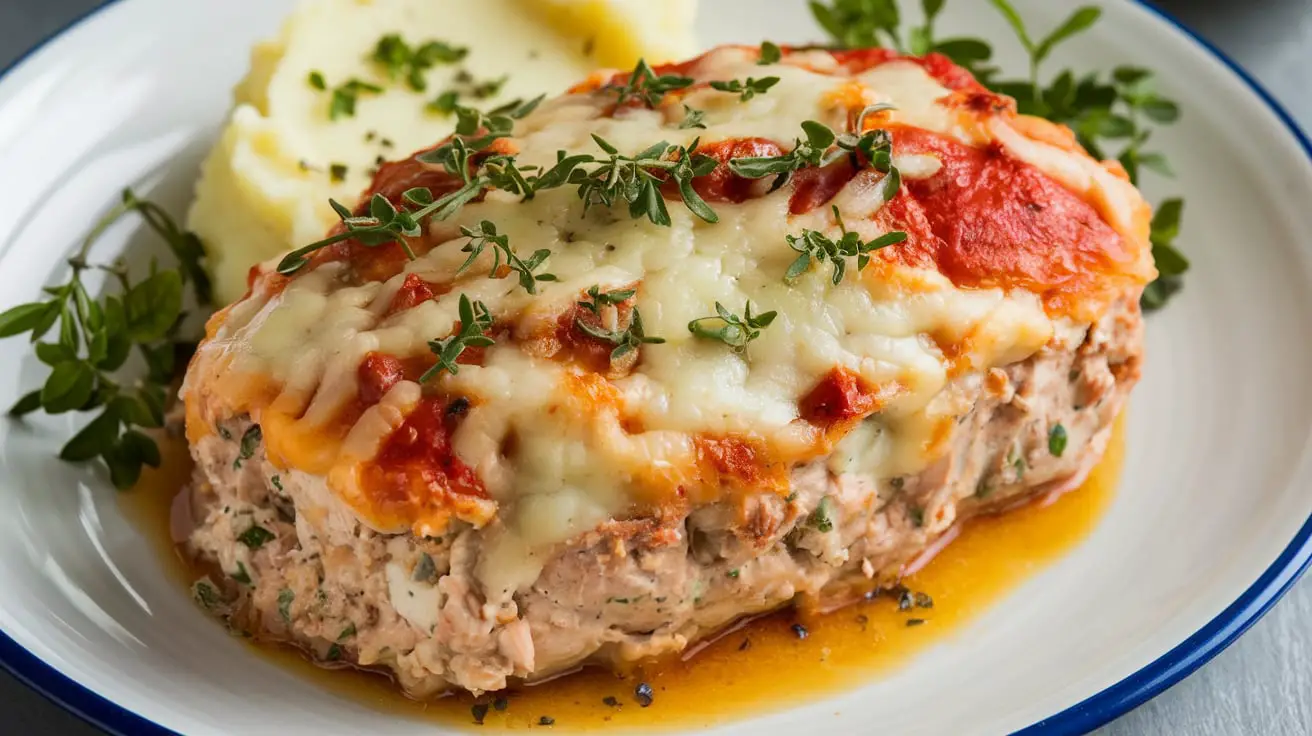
[0,0,1312,735]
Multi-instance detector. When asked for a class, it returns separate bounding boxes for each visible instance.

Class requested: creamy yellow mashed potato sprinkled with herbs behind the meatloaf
[189,0,695,302]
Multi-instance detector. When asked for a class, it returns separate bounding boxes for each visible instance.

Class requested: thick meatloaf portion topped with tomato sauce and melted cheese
[182,47,1153,697]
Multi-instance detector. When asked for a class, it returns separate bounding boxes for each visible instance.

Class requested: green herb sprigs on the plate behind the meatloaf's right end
[811,0,1189,310]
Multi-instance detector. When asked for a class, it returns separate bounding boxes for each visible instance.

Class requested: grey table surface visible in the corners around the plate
[0,0,1312,736]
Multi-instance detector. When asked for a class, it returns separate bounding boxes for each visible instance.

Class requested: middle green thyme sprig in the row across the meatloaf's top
[533,134,720,226]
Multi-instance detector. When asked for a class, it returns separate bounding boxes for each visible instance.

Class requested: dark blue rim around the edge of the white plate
[0,0,1312,736]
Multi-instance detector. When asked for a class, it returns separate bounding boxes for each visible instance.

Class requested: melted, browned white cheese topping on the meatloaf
[185,47,1152,590]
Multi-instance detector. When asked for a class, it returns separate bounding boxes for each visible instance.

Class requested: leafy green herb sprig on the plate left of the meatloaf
[0,189,210,488]
